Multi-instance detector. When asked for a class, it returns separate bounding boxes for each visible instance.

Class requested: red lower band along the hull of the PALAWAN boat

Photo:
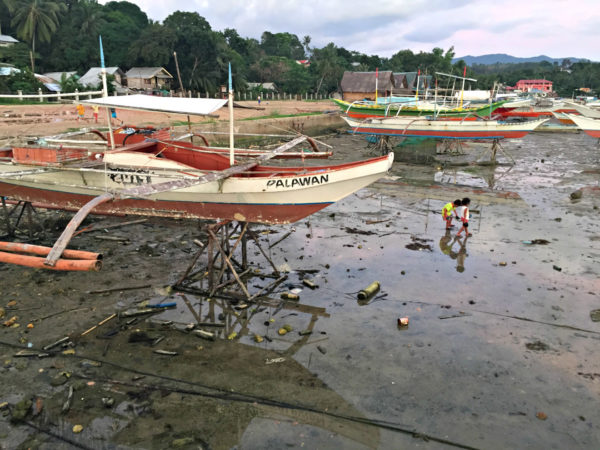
[0,183,332,224]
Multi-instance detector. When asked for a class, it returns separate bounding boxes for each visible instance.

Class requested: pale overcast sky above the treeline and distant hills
[101,0,600,61]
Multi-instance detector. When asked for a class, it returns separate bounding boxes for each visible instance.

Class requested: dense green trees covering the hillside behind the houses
[0,0,600,96]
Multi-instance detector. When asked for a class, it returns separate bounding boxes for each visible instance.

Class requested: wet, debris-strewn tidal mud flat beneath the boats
[0,128,600,449]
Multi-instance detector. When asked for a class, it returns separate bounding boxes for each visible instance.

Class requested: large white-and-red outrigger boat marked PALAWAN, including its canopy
[0,96,394,224]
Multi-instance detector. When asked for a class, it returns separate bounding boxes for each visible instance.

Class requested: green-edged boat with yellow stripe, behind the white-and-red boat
[332,98,507,119]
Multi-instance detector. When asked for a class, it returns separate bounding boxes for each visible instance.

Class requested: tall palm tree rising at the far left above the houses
[7,0,66,72]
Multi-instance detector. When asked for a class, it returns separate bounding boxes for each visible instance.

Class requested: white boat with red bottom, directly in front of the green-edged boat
[343,116,549,140]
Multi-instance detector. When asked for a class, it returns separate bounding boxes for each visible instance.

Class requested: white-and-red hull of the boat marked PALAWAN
[0,153,393,224]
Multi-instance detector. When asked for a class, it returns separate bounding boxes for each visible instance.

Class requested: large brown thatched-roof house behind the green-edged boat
[340,70,395,102]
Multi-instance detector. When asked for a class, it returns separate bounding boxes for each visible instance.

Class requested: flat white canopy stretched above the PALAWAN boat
[81,94,227,116]
